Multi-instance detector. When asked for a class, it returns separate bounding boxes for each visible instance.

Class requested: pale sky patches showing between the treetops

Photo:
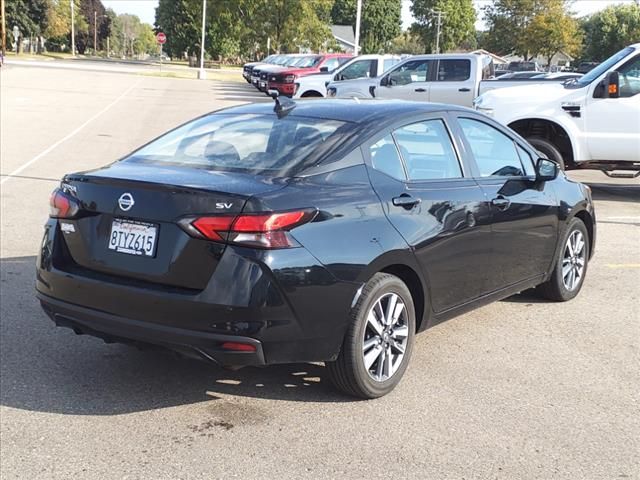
[102,0,633,30]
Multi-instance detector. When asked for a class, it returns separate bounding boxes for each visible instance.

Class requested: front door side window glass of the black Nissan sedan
[459,118,525,177]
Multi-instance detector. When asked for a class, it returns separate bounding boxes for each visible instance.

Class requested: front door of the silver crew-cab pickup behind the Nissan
[376,59,435,102]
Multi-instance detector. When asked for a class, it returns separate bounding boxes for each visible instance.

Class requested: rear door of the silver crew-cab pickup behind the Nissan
[429,58,476,107]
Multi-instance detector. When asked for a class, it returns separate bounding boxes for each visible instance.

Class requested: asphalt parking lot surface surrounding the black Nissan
[0,66,640,479]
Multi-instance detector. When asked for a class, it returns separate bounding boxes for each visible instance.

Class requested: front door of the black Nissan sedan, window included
[458,114,559,290]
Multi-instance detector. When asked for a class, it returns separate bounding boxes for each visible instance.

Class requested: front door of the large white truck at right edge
[584,55,640,162]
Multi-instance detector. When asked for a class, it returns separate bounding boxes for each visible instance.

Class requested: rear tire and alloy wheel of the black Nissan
[326,273,416,399]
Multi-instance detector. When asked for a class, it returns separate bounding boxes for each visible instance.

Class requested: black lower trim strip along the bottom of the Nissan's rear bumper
[36,292,266,366]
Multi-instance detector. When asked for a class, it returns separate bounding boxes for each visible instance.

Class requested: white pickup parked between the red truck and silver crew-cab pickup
[293,55,402,98]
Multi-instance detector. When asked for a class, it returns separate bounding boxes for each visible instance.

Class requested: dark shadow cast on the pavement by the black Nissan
[0,256,354,415]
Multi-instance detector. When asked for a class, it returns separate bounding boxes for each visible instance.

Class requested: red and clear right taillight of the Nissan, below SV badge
[180,209,316,248]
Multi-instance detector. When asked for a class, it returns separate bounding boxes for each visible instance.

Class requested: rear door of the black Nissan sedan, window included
[363,115,491,313]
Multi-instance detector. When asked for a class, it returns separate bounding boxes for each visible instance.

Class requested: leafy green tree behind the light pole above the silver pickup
[411,0,476,52]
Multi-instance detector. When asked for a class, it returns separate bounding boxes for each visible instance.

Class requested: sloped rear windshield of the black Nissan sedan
[122,113,348,176]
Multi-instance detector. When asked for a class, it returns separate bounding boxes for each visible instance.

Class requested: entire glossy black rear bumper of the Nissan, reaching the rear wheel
[36,220,360,365]
